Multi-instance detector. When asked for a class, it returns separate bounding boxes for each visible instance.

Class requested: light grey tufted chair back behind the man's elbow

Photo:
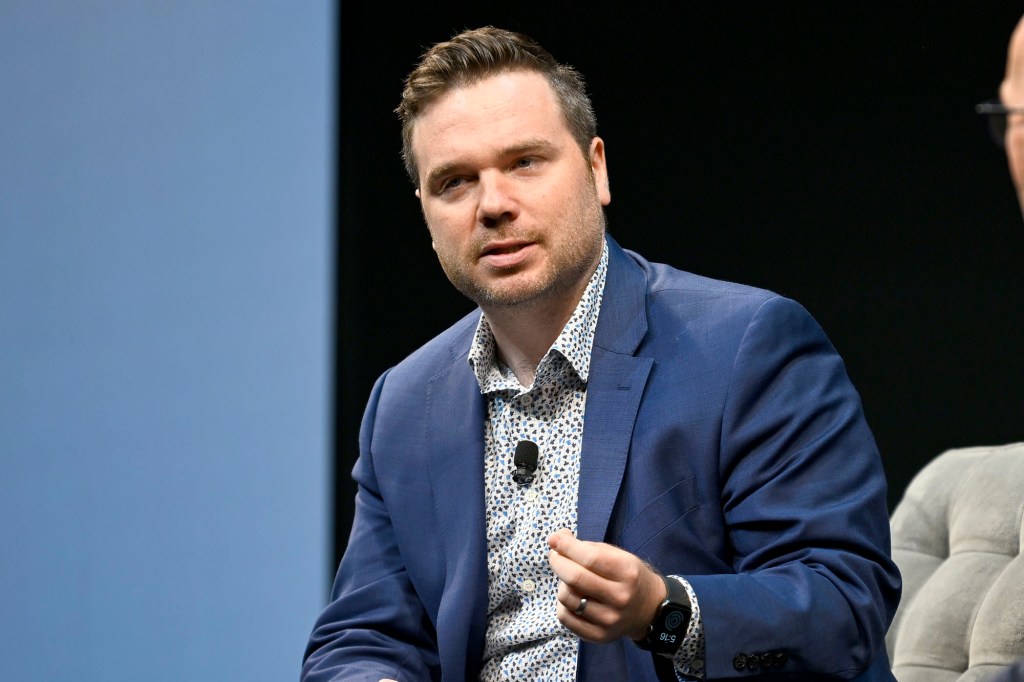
[886,442,1024,682]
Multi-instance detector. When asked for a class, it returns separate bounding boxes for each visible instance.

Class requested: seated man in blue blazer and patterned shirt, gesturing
[302,28,900,682]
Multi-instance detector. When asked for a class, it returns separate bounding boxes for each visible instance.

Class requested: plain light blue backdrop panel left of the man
[0,0,334,682]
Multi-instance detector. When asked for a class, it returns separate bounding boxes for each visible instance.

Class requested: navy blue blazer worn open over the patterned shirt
[302,237,900,682]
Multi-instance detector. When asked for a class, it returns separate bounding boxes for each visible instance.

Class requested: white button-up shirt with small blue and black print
[469,245,702,682]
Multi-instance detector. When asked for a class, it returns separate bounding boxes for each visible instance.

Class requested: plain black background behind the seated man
[334,1,1024,560]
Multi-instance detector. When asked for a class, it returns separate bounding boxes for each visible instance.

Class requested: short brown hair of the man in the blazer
[394,26,597,185]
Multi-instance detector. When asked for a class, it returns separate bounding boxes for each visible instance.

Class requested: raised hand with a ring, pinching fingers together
[548,528,668,643]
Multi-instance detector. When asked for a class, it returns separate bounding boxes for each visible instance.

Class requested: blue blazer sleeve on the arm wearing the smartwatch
[685,297,900,679]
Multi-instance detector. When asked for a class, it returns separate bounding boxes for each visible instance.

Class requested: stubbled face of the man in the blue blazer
[412,72,611,313]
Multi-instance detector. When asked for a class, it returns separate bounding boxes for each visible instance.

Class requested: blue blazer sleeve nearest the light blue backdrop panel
[301,374,439,682]
